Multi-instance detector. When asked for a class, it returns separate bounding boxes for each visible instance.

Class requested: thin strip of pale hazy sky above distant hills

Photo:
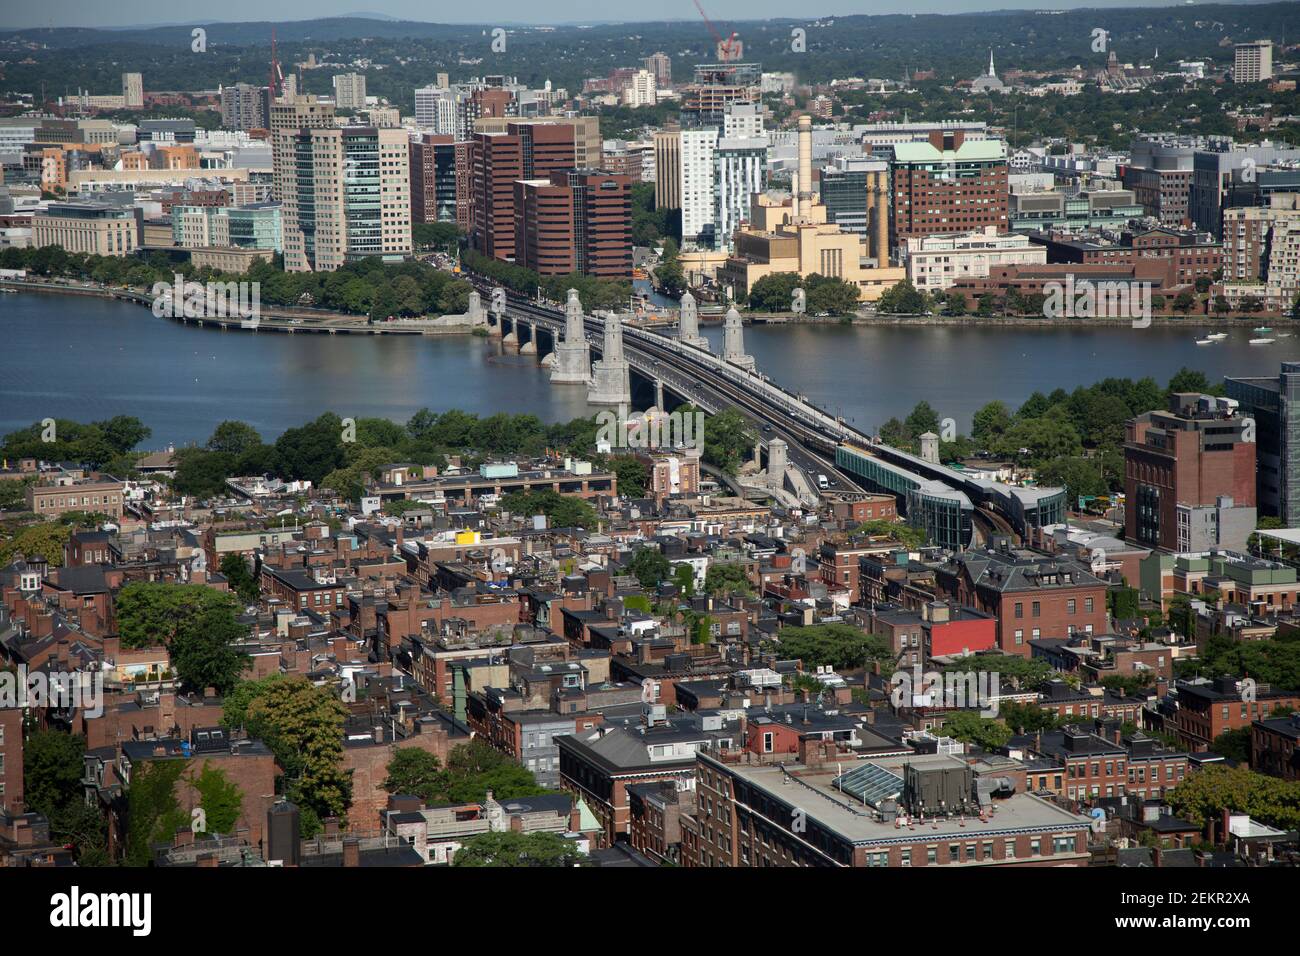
[0,0,1216,30]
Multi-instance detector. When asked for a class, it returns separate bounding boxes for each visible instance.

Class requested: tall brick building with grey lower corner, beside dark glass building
[1125,393,1257,553]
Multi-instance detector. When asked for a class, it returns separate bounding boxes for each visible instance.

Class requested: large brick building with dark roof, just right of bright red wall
[935,548,1108,657]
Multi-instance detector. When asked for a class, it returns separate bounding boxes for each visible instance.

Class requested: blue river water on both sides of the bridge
[0,294,1300,447]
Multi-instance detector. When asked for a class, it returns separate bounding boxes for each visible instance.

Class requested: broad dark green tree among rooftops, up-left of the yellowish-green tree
[116,581,248,693]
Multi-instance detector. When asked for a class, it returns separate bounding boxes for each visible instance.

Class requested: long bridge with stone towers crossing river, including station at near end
[471,280,1065,549]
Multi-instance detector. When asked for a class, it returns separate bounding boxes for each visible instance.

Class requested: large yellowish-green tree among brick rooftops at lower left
[246,676,352,817]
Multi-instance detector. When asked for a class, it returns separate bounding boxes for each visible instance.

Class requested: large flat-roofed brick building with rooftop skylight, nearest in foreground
[683,740,1088,868]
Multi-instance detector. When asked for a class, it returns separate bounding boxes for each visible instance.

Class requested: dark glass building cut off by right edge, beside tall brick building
[1223,362,1300,528]
